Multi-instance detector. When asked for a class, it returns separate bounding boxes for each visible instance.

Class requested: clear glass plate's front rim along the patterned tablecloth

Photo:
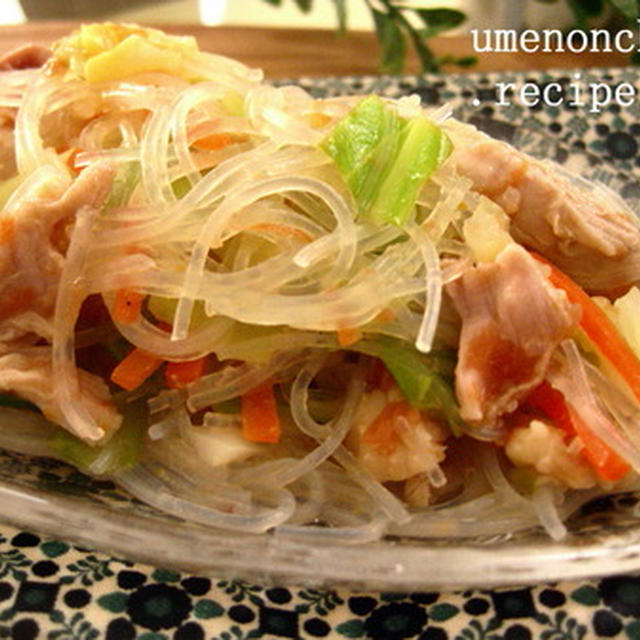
[0,481,640,591]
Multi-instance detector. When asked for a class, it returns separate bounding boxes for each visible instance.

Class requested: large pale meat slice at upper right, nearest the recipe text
[455,140,640,293]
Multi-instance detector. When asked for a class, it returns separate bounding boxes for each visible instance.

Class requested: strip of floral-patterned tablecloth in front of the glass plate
[0,526,640,640]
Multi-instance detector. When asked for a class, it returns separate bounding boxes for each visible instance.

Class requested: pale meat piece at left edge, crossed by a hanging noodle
[0,164,121,435]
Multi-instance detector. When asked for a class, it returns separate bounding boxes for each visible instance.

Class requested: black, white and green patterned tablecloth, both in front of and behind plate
[0,69,640,640]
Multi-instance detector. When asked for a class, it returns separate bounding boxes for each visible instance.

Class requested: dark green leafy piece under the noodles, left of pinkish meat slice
[353,338,464,435]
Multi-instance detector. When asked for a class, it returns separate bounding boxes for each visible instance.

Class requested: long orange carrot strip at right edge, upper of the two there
[532,254,640,400]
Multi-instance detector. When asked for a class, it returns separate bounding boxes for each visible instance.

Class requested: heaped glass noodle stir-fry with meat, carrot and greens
[0,24,640,542]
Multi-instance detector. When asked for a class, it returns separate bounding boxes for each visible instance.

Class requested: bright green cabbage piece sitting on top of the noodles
[321,96,452,225]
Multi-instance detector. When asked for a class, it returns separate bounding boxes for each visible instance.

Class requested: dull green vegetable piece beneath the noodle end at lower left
[51,400,147,475]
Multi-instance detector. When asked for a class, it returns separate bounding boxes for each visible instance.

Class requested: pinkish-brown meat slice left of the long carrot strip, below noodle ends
[447,243,578,429]
